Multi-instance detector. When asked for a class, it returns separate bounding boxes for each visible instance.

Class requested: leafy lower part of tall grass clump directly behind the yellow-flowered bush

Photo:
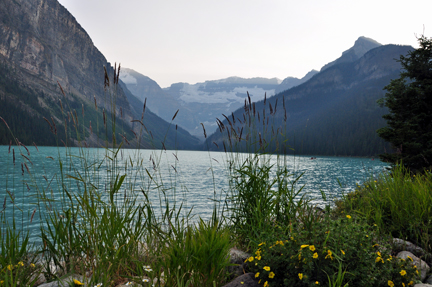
[226,153,311,252]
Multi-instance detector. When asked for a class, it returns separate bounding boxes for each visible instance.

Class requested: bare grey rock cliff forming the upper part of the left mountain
[0,0,130,119]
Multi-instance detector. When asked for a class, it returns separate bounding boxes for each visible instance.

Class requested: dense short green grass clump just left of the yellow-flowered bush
[159,219,232,287]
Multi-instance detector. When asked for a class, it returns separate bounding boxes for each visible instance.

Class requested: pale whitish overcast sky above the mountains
[59,0,432,88]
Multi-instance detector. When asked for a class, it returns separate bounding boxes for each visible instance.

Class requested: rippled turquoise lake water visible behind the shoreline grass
[0,146,386,242]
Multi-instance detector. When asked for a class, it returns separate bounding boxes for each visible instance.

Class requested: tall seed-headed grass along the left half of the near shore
[0,66,236,286]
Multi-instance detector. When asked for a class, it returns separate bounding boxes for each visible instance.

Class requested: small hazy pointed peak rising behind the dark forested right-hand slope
[321,36,381,72]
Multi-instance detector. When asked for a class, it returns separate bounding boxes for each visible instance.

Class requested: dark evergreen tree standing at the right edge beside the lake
[377,36,432,172]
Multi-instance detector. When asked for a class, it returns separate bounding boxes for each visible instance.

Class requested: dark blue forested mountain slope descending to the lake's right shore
[206,41,413,156]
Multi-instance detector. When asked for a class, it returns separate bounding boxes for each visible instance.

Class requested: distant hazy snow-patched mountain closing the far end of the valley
[120,72,280,140]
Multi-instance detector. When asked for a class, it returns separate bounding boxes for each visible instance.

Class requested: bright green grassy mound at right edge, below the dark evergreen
[334,165,432,253]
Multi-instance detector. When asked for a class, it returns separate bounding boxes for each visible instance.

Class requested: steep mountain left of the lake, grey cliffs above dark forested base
[0,0,196,150]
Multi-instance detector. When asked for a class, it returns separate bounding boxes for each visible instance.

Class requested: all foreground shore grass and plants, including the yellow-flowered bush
[0,68,431,287]
